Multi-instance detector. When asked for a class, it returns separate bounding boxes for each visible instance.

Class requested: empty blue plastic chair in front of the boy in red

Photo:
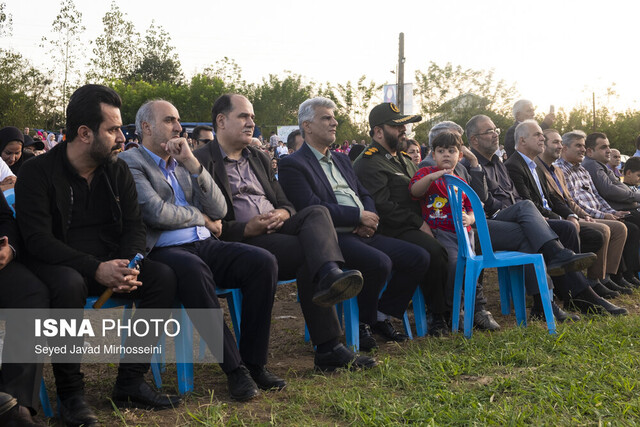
[444,175,556,338]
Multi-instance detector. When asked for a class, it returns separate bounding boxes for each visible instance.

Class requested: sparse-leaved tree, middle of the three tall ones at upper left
[87,1,141,82]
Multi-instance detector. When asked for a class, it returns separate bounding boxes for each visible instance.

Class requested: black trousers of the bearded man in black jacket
[33,259,176,398]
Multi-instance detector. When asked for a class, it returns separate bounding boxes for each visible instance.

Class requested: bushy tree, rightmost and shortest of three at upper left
[129,21,184,84]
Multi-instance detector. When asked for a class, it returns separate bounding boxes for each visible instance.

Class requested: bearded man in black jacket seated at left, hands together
[16,85,180,426]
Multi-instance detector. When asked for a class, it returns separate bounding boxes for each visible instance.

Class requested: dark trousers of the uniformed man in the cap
[396,229,449,314]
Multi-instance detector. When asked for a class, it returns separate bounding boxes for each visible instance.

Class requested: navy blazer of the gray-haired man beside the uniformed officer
[278,142,376,227]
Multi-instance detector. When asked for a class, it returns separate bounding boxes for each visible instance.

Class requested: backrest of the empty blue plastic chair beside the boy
[444,174,495,259]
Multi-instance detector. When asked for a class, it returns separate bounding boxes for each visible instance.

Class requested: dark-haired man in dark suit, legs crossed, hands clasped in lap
[194,95,375,371]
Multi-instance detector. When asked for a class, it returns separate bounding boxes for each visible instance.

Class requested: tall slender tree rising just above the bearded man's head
[41,0,85,110]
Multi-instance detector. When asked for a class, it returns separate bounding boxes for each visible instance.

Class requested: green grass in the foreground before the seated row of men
[183,315,640,425]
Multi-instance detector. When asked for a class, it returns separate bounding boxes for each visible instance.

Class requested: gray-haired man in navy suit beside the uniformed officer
[280,97,430,348]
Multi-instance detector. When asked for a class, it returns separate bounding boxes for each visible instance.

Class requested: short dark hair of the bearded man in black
[66,85,122,142]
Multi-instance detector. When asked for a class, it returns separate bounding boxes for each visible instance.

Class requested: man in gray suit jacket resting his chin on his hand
[120,100,286,401]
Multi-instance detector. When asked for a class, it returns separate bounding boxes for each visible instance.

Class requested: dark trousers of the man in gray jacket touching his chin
[149,237,278,373]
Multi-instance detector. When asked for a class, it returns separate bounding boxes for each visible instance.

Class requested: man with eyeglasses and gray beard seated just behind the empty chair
[462,115,627,316]
